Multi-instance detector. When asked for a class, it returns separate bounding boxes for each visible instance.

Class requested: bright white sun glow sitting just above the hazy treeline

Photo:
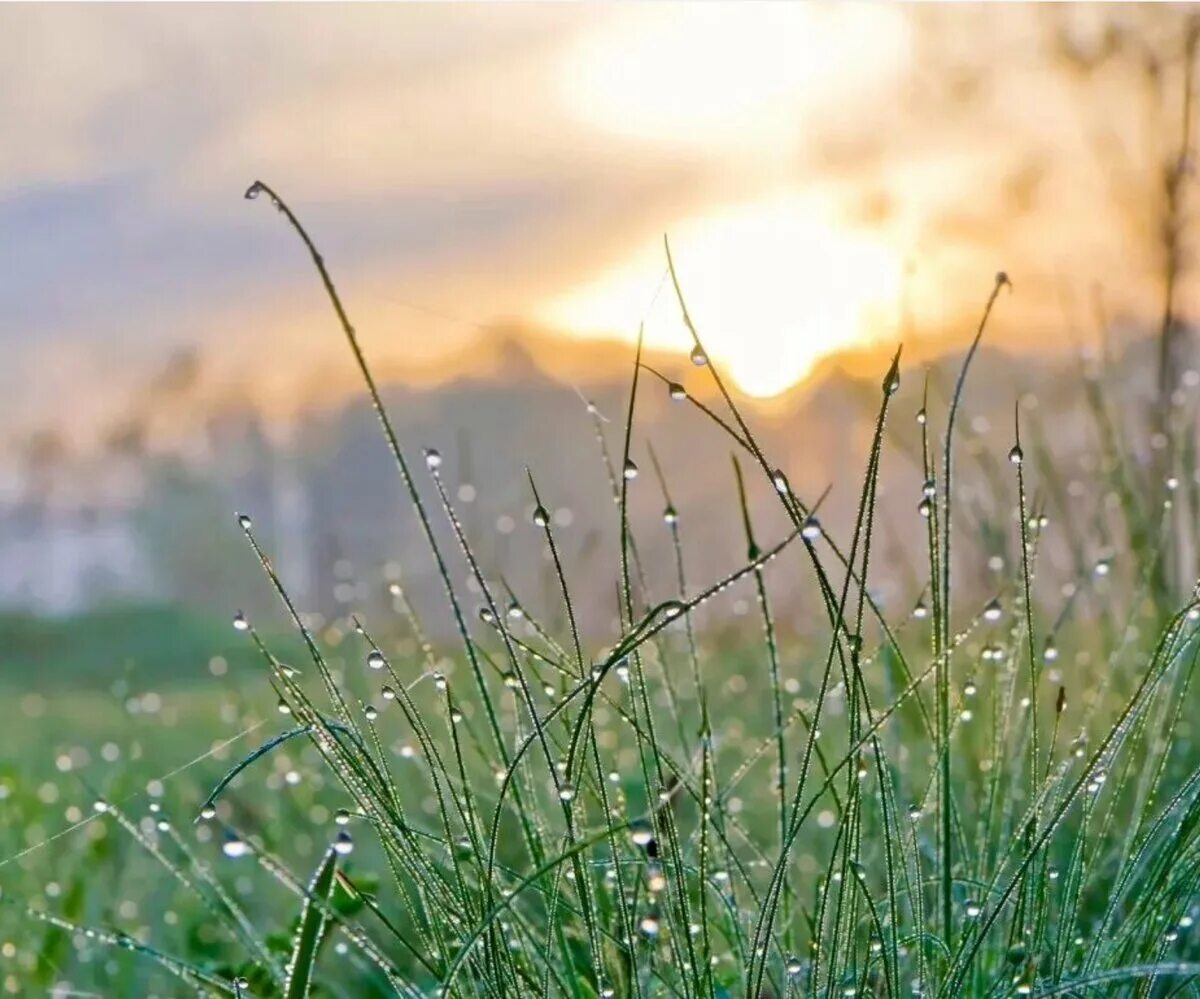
[539,195,904,397]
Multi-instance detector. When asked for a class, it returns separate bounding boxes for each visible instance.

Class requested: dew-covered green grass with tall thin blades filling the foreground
[0,183,1200,999]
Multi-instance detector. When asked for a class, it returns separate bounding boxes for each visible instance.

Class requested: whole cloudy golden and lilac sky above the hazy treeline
[0,4,1195,449]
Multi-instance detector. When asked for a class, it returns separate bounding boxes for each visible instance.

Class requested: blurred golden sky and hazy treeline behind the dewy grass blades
[0,4,1198,653]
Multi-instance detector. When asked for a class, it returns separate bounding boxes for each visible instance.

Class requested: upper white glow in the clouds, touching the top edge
[560,4,908,155]
